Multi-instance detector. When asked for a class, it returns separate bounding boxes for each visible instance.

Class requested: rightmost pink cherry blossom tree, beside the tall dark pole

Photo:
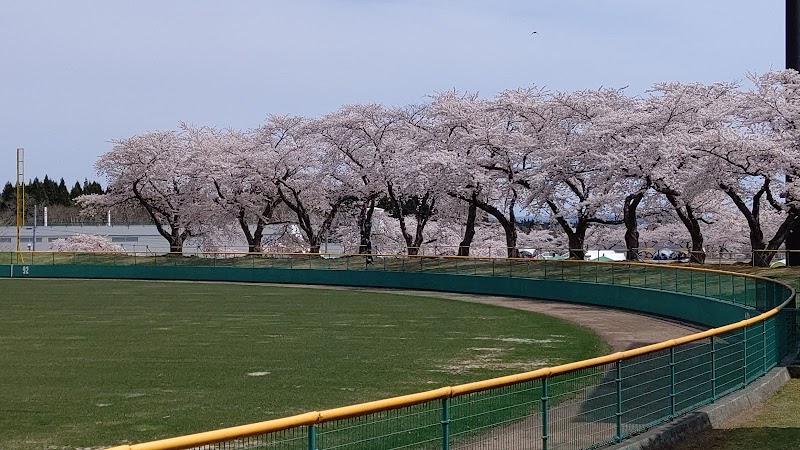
[720,70,800,266]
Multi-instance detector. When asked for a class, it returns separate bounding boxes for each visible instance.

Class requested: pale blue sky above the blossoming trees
[0,0,784,184]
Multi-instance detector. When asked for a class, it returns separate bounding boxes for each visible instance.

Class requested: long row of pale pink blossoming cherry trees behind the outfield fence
[81,71,800,265]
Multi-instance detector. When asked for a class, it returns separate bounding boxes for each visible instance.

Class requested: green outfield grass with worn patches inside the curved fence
[0,279,607,450]
